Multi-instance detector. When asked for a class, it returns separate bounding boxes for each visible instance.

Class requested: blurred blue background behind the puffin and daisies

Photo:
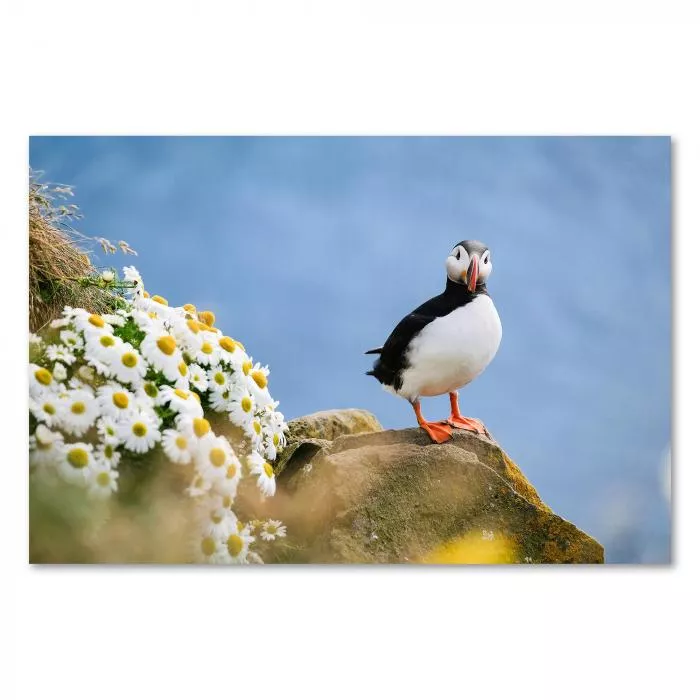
[30,137,671,563]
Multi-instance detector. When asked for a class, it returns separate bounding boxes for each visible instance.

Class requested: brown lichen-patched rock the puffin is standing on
[274,422,603,563]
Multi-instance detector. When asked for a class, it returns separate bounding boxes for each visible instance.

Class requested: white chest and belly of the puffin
[398,294,501,399]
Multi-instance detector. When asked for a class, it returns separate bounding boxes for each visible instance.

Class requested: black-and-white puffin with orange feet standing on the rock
[365,240,502,443]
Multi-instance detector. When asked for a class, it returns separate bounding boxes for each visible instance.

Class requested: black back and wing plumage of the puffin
[366,278,488,391]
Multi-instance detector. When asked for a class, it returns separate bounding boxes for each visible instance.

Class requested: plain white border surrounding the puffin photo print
[0,5,700,700]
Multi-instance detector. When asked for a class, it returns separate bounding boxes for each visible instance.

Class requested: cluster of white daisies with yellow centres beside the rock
[29,266,287,563]
